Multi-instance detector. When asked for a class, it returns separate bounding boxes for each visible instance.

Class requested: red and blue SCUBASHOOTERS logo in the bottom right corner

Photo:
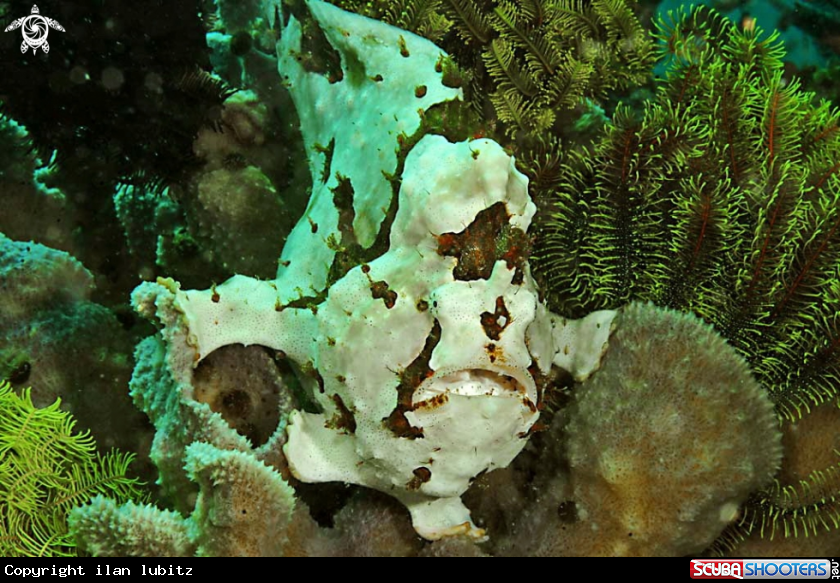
[691,559,832,579]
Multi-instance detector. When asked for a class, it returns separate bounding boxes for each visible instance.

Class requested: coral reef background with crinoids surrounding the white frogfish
[0,0,840,556]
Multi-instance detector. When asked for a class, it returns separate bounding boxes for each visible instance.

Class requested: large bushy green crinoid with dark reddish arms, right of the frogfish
[535,8,840,552]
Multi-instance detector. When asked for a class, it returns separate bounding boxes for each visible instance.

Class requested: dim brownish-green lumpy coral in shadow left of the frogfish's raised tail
[114,91,305,286]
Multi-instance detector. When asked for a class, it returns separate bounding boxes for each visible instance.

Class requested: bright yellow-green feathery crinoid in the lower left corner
[0,382,145,557]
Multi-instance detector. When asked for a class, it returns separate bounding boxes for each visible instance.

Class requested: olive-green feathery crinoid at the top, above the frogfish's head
[332,0,653,142]
